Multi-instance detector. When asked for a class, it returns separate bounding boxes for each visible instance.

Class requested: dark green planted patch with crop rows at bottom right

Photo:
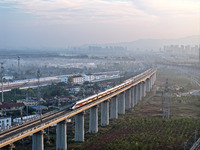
[104,118,200,150]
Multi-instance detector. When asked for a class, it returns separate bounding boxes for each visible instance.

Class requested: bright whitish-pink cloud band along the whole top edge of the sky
[0,0,200,23]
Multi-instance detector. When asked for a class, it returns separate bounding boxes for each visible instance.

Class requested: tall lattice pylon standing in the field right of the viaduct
[162,79,170,119]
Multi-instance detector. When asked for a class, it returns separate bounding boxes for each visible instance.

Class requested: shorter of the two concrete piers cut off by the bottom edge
[32,131,44,150]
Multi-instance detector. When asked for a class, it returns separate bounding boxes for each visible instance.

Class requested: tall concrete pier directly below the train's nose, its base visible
[75,112,84,142]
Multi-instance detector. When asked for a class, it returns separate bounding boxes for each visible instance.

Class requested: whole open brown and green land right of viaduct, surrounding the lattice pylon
[75,68,200,150]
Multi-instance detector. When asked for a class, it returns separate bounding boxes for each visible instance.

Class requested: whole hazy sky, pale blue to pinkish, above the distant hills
[0,0,200,48]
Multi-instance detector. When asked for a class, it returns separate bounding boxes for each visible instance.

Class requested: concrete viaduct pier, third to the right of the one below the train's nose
[110,96,118,119]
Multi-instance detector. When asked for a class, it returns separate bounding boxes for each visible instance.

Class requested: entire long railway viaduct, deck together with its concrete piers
[0,68,157,150]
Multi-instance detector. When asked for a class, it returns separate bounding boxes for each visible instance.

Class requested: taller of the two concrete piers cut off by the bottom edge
[56,120,67,150]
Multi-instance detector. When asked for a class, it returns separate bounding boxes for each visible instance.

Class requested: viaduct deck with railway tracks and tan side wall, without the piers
[0,69,155,148]
